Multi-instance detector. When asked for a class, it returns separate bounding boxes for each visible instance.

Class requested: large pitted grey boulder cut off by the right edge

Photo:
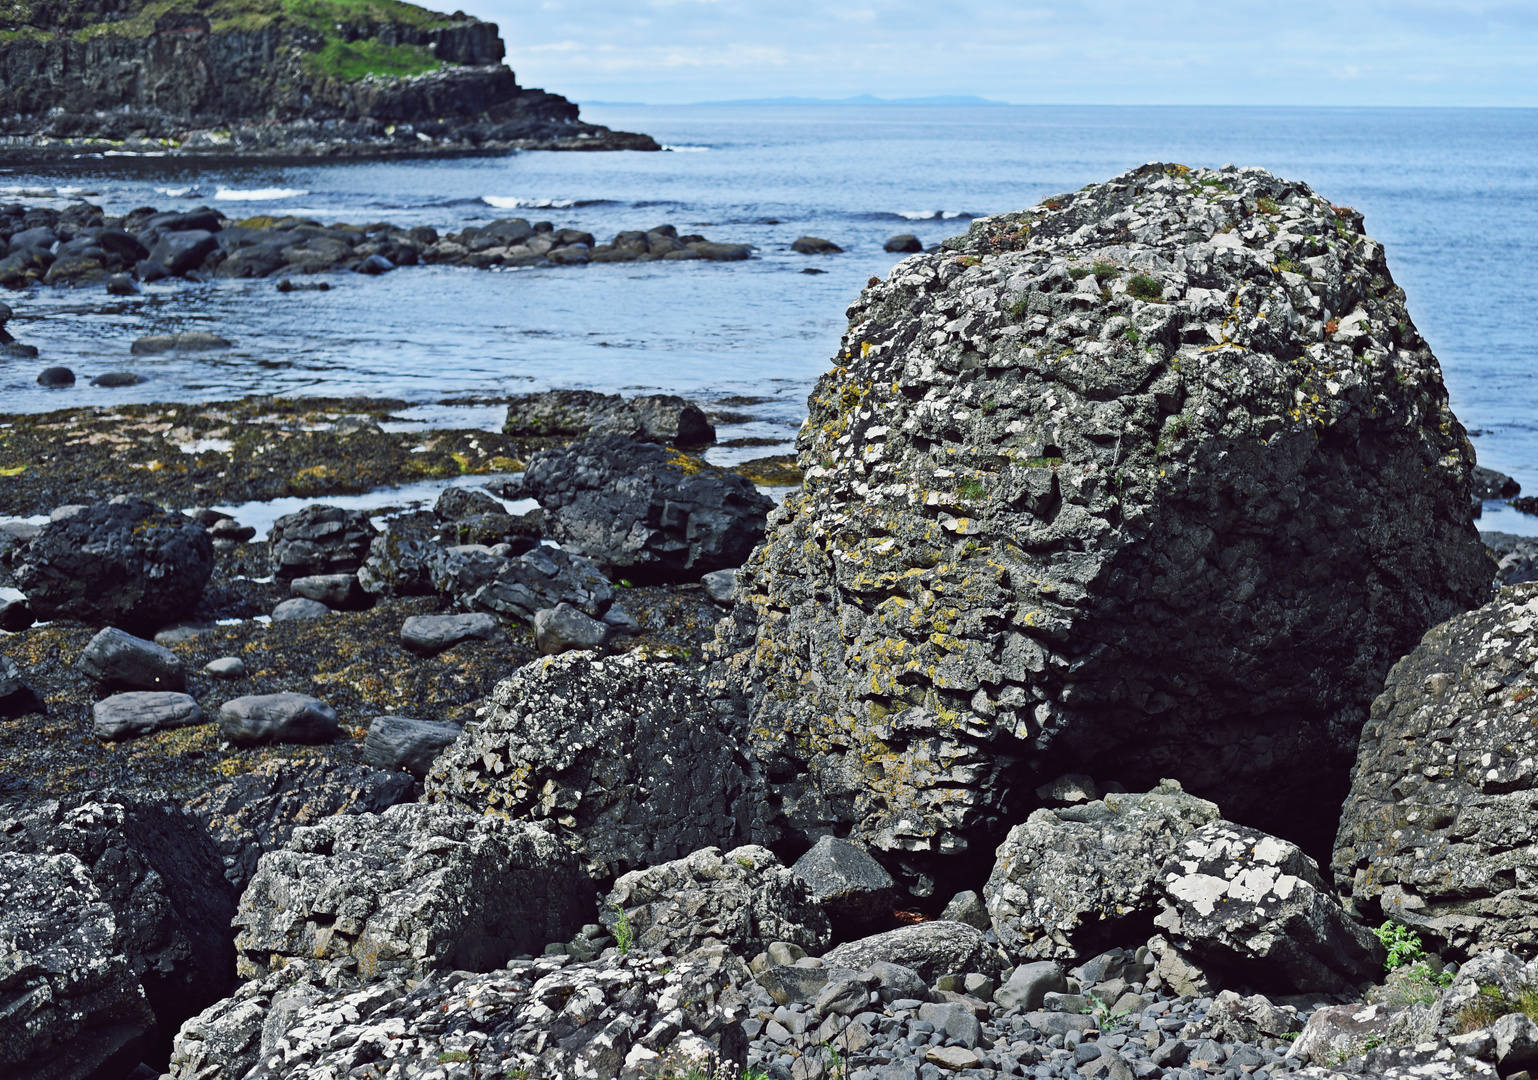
[1332,583,1538,955]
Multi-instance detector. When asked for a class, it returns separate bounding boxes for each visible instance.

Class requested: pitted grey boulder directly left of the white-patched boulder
[983,780,1221,960]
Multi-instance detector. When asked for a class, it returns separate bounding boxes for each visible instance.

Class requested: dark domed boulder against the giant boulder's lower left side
[424,652,772,875]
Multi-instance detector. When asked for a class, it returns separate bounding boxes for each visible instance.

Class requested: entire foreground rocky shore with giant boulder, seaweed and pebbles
[0,165,1538,1080]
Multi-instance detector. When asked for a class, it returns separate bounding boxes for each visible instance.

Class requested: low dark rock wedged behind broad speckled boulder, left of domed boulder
[188,758,414,891]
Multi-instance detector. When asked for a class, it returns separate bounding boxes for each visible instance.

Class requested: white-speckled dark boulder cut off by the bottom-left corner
[0,852,155,1080]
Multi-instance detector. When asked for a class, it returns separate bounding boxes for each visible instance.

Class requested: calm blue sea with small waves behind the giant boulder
[0,106,1538,534]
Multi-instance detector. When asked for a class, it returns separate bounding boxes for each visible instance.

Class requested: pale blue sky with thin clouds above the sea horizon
[455,0,1538,108]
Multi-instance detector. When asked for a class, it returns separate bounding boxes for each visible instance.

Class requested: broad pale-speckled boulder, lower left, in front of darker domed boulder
[234,803,592,980]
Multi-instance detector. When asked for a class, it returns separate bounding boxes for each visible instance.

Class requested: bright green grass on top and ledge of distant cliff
[0,0,455,82]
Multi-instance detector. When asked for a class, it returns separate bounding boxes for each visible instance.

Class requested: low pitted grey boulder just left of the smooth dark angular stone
[600,845,832,957]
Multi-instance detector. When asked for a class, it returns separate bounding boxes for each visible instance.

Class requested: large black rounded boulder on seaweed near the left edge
[14,495,214,631]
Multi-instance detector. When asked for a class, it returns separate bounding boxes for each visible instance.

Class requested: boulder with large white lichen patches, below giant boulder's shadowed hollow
[1154,822,1383,992]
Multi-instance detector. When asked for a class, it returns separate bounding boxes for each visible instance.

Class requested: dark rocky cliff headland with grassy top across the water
[0,0,658,158]
